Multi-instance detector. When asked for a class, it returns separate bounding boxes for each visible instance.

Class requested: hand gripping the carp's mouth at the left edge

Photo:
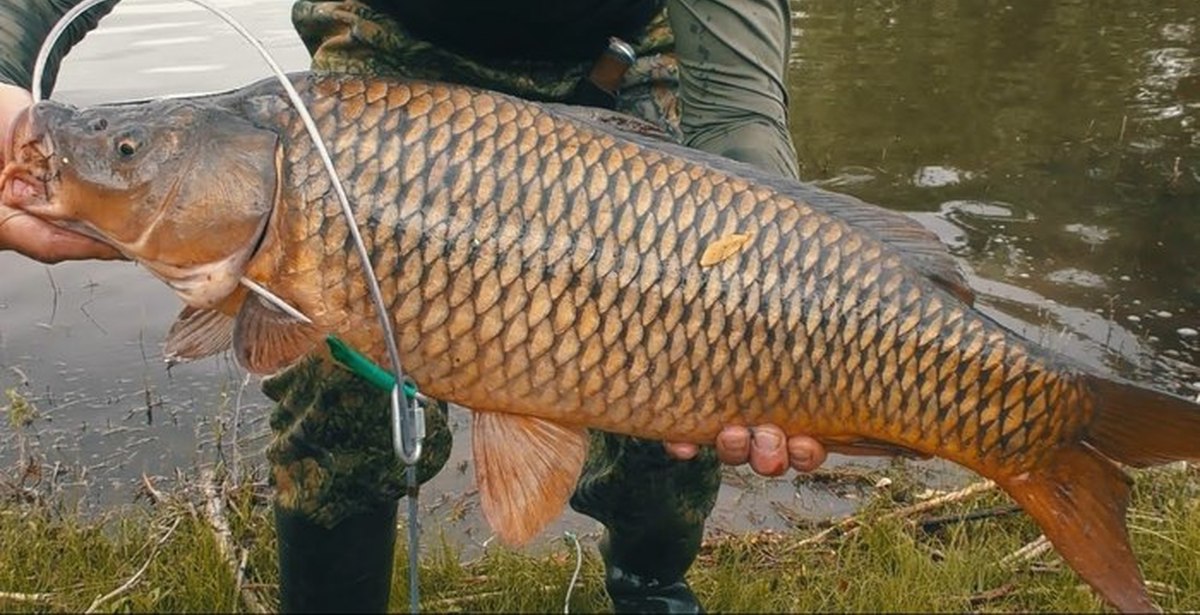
[0,84,121,263]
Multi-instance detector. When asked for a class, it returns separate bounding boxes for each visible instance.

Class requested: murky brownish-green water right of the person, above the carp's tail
[791,0,1200,394]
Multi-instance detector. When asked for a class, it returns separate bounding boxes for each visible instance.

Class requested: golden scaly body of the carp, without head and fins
[262,76,1091,472]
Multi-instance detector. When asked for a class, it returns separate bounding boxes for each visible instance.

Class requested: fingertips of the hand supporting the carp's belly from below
[664,425,826,476]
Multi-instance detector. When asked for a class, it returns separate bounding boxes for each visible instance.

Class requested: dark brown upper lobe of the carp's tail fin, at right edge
[1084,377,1200,467]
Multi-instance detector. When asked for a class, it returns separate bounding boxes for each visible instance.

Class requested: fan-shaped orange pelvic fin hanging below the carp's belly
[470,412,588,547]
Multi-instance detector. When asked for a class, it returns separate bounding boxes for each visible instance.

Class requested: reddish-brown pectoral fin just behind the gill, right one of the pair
[233,294,320,374]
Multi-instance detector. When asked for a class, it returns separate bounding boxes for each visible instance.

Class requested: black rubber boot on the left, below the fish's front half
[275,502,396,613]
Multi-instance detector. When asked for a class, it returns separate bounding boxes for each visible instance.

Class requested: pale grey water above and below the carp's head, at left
[0,0,306,506]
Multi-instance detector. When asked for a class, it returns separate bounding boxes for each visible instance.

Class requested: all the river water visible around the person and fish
[0,0,1200,542]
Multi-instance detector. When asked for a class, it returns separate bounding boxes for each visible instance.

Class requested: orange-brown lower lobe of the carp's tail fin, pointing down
[997,444,1159,613]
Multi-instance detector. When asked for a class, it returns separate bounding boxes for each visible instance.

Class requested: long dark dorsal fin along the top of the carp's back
[547,106,974,305]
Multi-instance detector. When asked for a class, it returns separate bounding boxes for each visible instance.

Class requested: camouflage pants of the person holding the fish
[263,0,720,542]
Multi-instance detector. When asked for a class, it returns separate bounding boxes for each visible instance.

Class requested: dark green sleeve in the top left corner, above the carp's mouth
[0,0,118,94]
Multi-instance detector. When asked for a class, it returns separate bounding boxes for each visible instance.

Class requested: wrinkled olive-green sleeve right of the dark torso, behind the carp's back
[667,0,799,178]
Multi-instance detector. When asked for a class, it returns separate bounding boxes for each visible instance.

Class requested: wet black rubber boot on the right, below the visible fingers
[600,525,704,613]
